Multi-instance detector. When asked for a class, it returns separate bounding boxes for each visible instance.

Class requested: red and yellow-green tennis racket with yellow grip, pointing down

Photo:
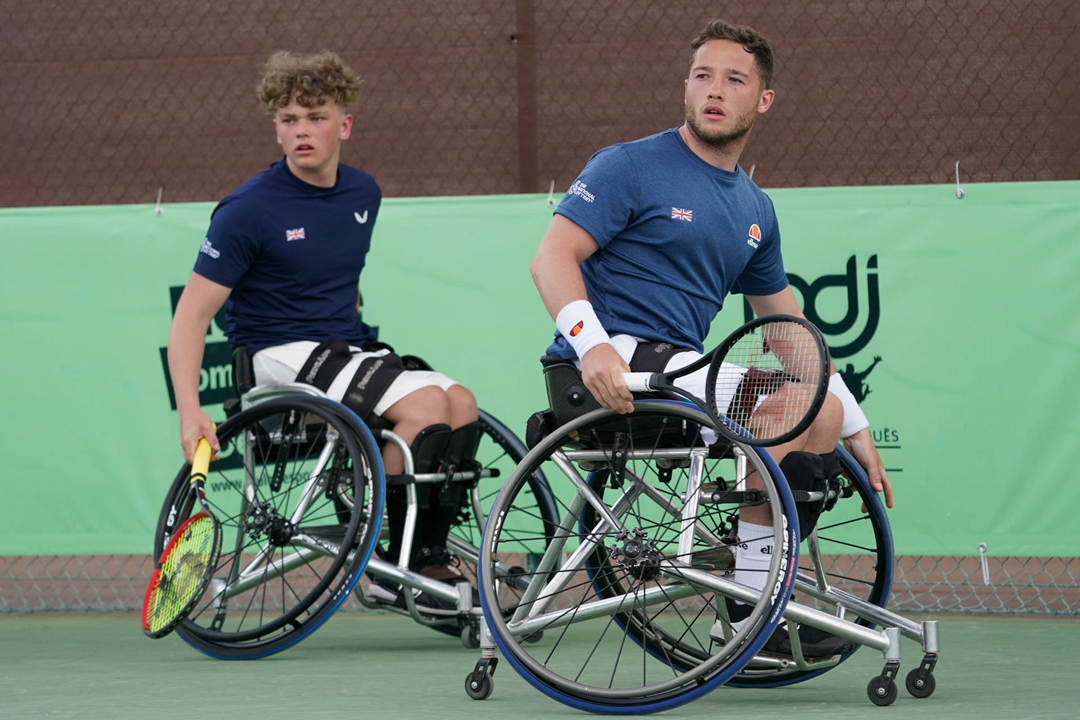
[143,438,221,638]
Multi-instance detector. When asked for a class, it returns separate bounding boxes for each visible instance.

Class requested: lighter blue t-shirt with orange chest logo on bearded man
[548,128,787,358]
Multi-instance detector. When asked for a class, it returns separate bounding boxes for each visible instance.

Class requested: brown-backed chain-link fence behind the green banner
[0,0,1080,613]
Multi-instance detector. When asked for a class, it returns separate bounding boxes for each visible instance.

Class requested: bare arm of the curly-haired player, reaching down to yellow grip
[168,272,232,462]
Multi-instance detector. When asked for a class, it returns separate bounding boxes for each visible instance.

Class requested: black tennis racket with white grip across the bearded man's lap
[623,315,829,446]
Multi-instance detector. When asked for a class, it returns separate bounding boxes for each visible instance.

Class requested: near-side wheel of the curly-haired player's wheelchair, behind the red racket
[154,394,383,660]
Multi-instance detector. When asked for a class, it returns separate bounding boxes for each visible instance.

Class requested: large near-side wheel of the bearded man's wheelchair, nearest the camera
[481,402,798,714]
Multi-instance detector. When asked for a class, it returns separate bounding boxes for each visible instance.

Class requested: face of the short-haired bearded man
[684,40,773,150]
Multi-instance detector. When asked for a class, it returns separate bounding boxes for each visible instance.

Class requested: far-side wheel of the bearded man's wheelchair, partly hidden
[728,447,895,688]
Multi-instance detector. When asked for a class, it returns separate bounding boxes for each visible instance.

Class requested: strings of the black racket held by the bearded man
[713,321,827,440]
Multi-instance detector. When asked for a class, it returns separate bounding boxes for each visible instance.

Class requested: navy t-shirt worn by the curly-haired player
[194,160,382,353]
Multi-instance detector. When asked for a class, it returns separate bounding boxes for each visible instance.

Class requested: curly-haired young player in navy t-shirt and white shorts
[168,53,478,602]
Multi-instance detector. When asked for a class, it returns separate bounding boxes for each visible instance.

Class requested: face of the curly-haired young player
[273,99,352,176]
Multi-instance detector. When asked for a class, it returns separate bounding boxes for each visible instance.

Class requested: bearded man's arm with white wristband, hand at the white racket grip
[529,214,634,413]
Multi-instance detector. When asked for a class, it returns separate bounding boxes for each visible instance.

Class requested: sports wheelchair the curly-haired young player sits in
[154,348,556,660]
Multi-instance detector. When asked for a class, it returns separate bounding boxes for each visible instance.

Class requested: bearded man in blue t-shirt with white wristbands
[531,21,892,655]
